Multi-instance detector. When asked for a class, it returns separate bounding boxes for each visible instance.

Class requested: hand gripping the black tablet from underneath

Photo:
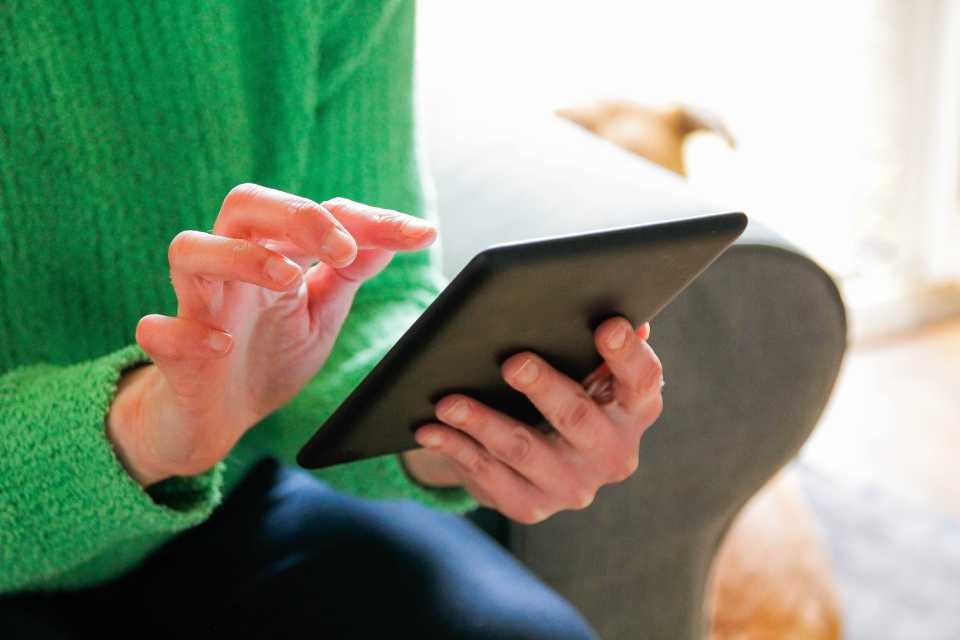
[402,317,663,524]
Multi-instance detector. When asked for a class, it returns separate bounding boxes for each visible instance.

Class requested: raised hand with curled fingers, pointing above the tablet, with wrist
[107,184,437,486]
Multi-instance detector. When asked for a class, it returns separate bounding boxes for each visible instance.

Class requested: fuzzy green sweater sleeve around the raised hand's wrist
[0,343,222,593]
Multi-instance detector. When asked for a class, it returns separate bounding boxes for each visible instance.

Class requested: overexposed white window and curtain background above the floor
[419,0,960,328]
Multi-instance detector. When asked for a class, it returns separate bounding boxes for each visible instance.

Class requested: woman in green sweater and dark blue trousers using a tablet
[0,0,662,638]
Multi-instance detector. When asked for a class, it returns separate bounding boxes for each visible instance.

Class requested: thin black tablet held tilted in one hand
[297,213,747,468]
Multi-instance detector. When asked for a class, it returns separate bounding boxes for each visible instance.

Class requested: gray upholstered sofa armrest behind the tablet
[421,102,846,640]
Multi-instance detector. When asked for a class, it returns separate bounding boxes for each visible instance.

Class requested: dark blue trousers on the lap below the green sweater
[0,460,596,639]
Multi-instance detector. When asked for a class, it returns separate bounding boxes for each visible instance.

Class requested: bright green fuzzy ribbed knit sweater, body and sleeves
[0,0,476,592]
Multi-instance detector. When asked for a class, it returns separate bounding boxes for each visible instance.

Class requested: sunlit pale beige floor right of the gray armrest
[801,318,960,516]
